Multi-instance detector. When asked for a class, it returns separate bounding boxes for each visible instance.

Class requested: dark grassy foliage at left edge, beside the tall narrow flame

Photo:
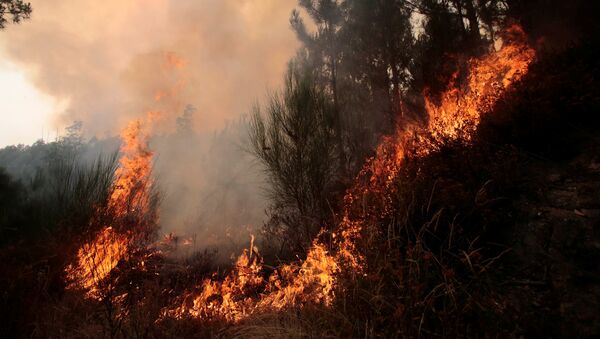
[0,154,116,244]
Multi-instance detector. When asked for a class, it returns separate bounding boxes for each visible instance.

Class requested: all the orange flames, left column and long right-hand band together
[68,26,535,322]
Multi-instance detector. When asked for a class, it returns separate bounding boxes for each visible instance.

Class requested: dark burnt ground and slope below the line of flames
[0,41,600,338]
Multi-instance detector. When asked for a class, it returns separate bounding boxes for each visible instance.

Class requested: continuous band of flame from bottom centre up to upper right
[164,26,535,321]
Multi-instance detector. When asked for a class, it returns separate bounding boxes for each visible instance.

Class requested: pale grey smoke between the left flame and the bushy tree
[151,118,267,256]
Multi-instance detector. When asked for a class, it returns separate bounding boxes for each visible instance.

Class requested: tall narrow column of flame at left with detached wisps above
[66,53,186,297]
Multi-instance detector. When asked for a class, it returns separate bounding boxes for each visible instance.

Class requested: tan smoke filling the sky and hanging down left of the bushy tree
[0,0,298,255]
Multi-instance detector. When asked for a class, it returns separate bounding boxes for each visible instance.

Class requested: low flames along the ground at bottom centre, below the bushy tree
[163,237,339,321]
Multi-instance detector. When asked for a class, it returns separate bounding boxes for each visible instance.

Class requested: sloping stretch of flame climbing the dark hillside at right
[338,26,535,269]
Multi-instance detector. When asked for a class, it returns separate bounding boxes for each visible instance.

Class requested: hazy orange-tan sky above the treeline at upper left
[0,0,298,146]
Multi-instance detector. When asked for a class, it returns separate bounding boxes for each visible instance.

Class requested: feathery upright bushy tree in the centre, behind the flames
[250,61,337,254]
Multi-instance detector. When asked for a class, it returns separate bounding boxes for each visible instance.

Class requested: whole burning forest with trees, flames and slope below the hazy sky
[0,0,600,338]
